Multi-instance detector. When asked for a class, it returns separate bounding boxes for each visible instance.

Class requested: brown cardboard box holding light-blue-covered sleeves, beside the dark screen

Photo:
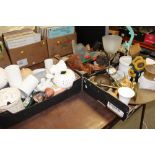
[47,33,77,57]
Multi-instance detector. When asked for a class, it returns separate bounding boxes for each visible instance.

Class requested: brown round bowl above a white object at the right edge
[144,65,155,81]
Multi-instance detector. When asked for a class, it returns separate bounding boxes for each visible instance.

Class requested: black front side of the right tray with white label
[83,77,140,120]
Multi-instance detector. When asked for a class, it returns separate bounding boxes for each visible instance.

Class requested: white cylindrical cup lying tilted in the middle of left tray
[19,75,39,96]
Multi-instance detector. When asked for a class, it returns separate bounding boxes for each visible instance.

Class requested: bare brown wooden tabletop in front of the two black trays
[12,92,118,129]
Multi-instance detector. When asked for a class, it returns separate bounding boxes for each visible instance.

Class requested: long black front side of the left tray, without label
[0,78,82,128]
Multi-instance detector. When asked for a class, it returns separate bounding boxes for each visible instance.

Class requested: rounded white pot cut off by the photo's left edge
[0,68,8,89]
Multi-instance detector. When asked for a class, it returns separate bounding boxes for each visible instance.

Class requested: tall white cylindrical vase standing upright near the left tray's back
[5,65,22,88]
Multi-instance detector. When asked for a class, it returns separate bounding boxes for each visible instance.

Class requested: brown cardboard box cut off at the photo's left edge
[0,41,11,68]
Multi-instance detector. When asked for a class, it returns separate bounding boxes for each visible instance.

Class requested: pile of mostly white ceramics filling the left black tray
[0,59,76,113]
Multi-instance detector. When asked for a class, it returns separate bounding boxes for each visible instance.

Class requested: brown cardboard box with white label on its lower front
[8,40,48,67]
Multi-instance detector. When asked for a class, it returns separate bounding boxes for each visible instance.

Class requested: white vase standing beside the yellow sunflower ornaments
[118,56,132,76]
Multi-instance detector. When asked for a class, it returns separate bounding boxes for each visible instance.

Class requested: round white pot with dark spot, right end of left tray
[53,69,76,89]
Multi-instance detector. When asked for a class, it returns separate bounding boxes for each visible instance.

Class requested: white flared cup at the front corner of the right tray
[118,87,135,105]
